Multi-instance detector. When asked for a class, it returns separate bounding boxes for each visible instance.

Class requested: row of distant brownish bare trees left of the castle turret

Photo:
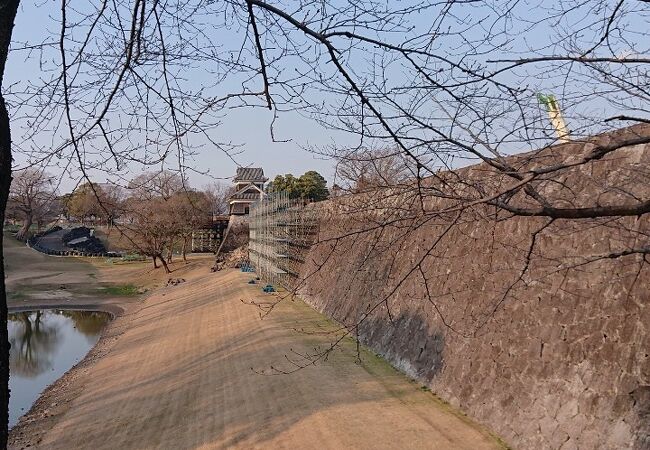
[7,169,232,271]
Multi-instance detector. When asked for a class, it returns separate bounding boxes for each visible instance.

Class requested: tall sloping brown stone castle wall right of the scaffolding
[300,127,650,449]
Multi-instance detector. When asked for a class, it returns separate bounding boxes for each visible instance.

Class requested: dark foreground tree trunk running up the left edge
[0,0,20,448]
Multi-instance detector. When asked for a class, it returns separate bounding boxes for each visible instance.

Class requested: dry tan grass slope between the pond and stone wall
[11,262,499,449]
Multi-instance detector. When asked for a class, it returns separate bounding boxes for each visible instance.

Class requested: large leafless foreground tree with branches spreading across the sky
[0,0,650,444]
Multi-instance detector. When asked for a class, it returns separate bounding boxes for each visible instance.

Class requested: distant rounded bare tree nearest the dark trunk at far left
[8,168,56,241]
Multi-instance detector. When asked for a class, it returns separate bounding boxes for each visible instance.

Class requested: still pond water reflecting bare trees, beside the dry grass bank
[8,310,110,426]
